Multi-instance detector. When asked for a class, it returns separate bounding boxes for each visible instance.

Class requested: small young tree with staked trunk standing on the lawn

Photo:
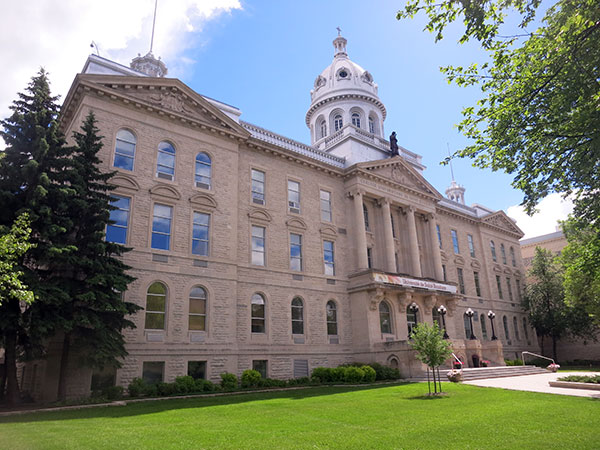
[409,322,452,392]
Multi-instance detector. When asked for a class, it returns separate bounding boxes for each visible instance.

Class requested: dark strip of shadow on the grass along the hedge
[0,382,411,424]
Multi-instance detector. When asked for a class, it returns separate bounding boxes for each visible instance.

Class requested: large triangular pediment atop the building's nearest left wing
[73,74,250,137]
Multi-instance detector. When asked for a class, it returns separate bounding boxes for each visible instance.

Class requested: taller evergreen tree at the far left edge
[0,69,69,404]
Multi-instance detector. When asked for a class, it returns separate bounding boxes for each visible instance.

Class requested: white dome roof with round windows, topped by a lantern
[306,36,386,125]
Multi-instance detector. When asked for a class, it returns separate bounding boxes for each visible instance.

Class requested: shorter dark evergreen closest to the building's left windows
[51,113,140,399]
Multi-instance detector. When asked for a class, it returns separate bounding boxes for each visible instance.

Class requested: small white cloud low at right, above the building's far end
[506,194,573,239]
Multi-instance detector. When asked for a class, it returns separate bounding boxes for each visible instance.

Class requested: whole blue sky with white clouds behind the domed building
[0,0,569,237]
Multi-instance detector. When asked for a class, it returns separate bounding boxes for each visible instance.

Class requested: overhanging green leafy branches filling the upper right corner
[397,0,600,320]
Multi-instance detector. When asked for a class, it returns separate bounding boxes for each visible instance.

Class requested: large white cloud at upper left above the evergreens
[0,0,242,125]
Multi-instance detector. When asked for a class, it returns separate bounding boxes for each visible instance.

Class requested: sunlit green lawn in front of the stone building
[0,383,600,450]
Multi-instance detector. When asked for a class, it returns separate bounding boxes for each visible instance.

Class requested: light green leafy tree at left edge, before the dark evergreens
[0,214,34,405]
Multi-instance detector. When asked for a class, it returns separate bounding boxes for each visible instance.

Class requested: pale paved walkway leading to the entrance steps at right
[464,371,600,399]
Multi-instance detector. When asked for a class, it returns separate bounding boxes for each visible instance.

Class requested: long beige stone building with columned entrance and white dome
[21,36,537,399]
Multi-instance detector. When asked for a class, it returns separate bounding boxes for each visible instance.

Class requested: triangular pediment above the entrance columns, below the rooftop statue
[358,156,442,199]
